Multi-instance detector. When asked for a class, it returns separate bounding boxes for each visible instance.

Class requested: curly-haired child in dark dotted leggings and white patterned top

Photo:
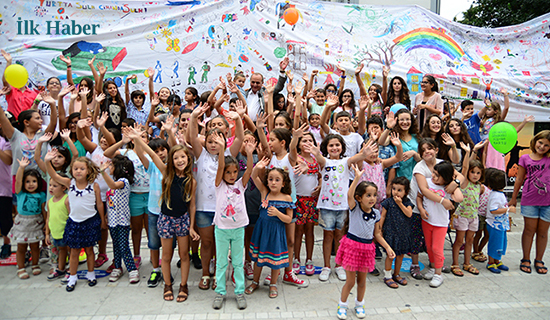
[101,155,139,283]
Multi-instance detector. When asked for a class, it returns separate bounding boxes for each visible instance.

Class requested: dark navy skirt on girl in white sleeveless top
[63,214,101,249]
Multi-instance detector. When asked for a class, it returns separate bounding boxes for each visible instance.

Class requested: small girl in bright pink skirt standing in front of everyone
[335,164,396,319]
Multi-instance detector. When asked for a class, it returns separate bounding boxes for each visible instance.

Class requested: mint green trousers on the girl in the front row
[214,226,245,295]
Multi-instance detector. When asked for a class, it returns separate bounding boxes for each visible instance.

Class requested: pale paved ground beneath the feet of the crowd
[0,210,550,320]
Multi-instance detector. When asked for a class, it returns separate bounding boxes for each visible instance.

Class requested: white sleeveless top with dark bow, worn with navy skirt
[68,179,97,222]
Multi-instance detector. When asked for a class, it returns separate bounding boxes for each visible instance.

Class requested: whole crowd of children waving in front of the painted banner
[0,51,550,319]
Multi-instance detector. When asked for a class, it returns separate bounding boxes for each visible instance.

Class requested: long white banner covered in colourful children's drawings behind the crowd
[0,0,550,122]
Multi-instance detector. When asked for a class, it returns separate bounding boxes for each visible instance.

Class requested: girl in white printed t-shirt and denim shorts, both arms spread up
[307,134,376,281]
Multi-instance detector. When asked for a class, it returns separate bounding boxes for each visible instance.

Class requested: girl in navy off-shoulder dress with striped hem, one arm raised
[245,158,295,298]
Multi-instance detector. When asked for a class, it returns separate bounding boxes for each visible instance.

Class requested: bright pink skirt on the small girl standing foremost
[336,236,376,272]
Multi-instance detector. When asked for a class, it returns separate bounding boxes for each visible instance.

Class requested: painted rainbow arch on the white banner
[393,28,464,60]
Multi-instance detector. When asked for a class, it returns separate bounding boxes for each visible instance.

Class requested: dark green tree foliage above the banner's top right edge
[460,0,550,28]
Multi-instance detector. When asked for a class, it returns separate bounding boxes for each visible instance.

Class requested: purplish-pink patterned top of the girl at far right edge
[519,154,550,206]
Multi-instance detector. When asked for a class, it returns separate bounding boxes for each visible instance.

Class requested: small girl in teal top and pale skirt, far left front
[8,158,46,279]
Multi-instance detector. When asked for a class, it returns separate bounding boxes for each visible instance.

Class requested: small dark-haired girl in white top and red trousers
[416,161,463,288]
